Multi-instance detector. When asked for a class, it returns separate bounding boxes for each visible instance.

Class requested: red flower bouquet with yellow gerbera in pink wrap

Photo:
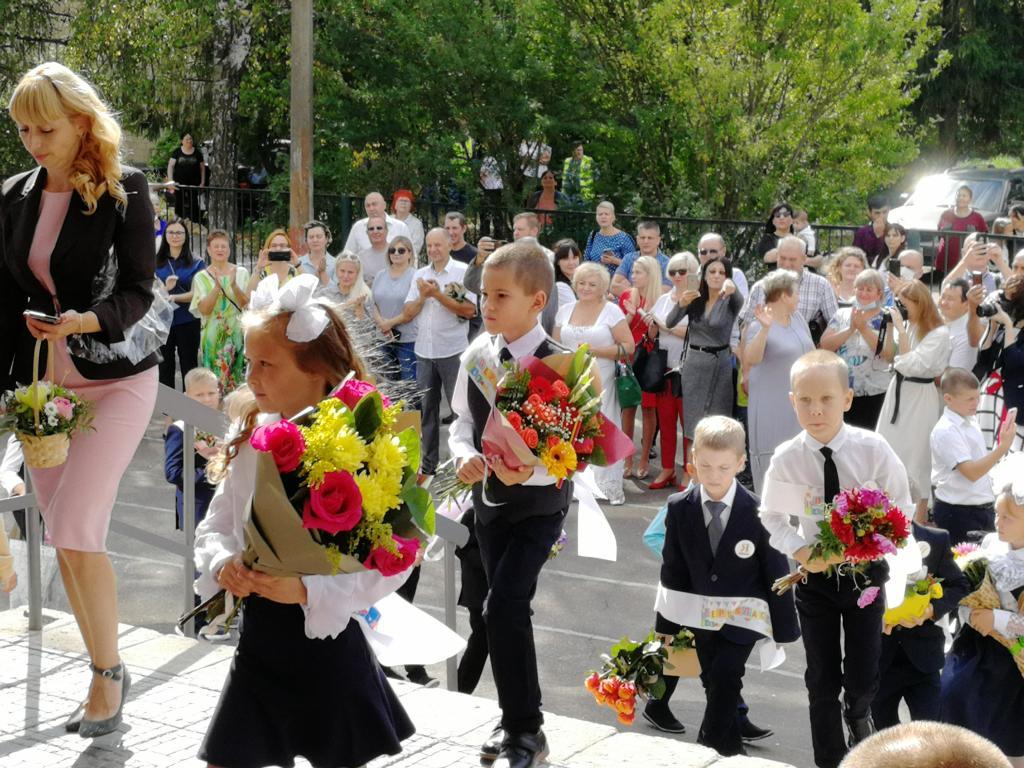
[482,345,633,486]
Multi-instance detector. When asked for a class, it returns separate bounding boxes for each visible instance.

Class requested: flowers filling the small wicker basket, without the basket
[0,381,93,437]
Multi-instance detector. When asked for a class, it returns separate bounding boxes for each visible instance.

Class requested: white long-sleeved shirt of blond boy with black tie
[761,424,913,556]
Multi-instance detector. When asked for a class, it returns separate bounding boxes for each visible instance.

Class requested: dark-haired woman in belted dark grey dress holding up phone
[669,256,743,440]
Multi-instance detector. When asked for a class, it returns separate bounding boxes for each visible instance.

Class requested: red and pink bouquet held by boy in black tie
[772,488,910,608]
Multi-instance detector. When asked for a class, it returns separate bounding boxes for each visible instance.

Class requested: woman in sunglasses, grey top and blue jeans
[373,234,416,381]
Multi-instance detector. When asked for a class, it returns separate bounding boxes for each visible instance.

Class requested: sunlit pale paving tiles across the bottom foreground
[0,608,784,768]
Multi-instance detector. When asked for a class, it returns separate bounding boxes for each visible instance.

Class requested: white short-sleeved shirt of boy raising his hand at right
[931,407,995,505]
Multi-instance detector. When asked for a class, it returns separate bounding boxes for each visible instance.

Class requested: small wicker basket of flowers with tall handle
[0,340,92,469]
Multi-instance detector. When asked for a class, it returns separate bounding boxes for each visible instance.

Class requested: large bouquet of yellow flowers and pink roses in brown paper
[180,378,434,624]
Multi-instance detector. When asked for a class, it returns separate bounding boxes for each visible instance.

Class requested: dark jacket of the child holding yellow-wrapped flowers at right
[879,523,971,674]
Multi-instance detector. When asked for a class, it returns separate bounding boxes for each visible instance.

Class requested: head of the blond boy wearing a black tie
[790,349,853,442]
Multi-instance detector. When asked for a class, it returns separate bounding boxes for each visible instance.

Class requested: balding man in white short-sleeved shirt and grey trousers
[404,227,476,475]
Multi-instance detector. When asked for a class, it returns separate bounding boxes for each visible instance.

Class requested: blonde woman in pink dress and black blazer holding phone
[0,62,158,738]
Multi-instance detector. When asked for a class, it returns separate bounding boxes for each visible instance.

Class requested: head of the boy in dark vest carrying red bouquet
[480,241,555,341]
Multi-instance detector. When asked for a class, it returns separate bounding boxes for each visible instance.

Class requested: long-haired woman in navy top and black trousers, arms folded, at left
[157,218,206,389]
